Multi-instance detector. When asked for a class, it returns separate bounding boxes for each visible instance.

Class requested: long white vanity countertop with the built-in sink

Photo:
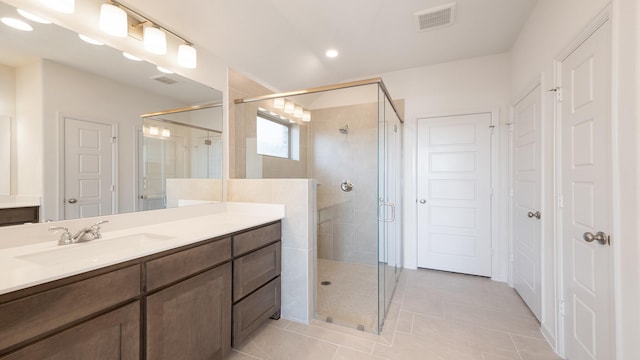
[0,205,284,294]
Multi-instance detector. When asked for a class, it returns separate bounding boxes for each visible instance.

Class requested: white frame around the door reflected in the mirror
[57,112,120,220]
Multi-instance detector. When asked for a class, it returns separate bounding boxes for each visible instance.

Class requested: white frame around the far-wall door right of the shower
[412,106,508,282]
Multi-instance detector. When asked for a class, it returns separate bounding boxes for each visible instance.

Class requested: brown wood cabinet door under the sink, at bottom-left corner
[2,301,140,360]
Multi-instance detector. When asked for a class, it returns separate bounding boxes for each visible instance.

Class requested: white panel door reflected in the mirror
[64,118,115,219]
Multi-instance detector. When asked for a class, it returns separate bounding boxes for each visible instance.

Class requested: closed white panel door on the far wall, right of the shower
[417,113,491,276]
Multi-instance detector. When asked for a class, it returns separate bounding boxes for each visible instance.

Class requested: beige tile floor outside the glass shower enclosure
[225,270,559,360]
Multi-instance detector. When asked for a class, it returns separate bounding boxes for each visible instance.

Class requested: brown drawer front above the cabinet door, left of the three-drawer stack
[146,238,231,291]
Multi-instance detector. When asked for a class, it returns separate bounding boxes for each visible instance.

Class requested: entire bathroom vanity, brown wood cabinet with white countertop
[0,207,281,360]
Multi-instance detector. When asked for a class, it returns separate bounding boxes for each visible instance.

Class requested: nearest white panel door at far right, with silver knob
[560,21,614,360]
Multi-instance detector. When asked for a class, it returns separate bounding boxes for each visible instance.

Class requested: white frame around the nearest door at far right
[554,5,620,357]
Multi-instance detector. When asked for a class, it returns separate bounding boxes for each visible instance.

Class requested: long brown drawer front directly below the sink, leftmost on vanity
[0,265,140,350]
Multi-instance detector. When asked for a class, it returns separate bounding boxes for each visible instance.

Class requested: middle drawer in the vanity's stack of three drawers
[233,241,281,302]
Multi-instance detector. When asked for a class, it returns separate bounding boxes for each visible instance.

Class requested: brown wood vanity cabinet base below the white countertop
[0,222,281,360]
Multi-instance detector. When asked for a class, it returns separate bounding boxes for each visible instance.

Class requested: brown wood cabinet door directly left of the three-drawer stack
[147,263,231,360]
